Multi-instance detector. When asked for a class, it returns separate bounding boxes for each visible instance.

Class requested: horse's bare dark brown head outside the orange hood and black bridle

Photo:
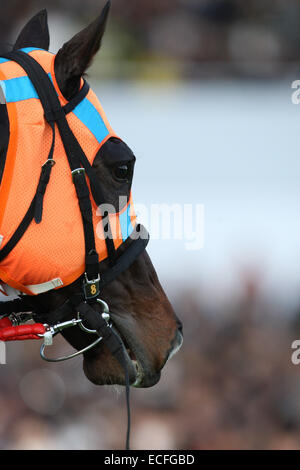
[3,2,182,387]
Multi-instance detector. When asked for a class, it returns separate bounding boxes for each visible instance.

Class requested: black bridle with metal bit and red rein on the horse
[0,51,149,449]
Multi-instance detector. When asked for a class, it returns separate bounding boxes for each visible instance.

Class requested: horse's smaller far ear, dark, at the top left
[14,10,50,51]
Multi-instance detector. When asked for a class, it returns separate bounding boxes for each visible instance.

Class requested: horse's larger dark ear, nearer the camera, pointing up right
[55,1,110,100]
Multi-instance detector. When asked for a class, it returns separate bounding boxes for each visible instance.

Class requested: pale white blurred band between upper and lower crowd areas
[91,80,300,304]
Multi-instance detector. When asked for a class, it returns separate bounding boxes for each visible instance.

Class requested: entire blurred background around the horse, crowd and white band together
[0,0,300,449]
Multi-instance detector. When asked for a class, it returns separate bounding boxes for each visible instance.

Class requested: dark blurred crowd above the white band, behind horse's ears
[0,0,300,78]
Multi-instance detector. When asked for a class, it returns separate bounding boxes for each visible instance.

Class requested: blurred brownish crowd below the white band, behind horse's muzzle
[0,280,300,450]
